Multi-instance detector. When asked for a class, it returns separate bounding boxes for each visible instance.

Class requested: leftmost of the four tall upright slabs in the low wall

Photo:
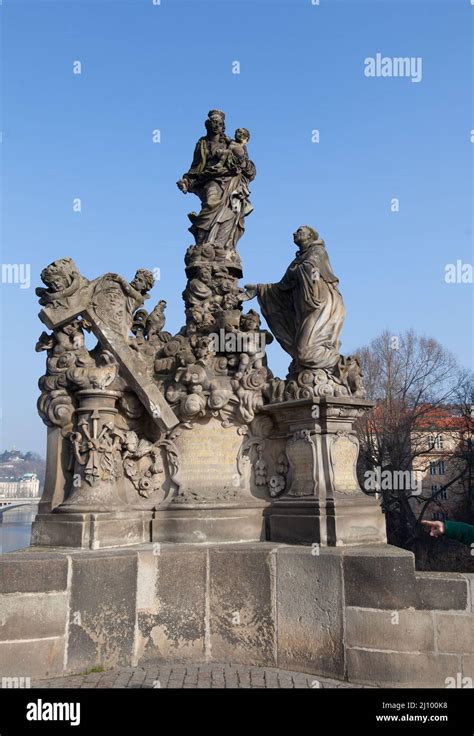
[67,551,137,671]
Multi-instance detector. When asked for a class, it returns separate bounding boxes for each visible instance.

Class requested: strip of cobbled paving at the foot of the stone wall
[32,664,364,689]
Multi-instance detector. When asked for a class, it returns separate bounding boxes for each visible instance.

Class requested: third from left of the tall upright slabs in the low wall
[209,544,276,666]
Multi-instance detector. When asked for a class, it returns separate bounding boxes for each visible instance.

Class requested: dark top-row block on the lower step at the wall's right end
[416,572,470,611]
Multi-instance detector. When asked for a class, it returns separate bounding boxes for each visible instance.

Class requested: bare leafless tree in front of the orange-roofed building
[357,330,467,548]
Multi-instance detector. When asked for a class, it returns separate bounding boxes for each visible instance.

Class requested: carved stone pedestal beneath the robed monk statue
[262,397,386,546]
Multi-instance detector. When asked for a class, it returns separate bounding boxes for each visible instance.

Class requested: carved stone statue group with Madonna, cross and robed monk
[37,110,364,512]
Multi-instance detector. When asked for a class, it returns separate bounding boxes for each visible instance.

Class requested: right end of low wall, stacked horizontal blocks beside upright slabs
[345,548,474,687]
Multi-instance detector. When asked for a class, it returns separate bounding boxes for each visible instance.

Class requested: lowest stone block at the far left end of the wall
[0,636,65,677]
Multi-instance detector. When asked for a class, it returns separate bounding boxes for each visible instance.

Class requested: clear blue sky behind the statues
[0,0,474,453]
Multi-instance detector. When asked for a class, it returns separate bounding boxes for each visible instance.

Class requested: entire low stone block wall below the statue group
[0,543,474,688]
